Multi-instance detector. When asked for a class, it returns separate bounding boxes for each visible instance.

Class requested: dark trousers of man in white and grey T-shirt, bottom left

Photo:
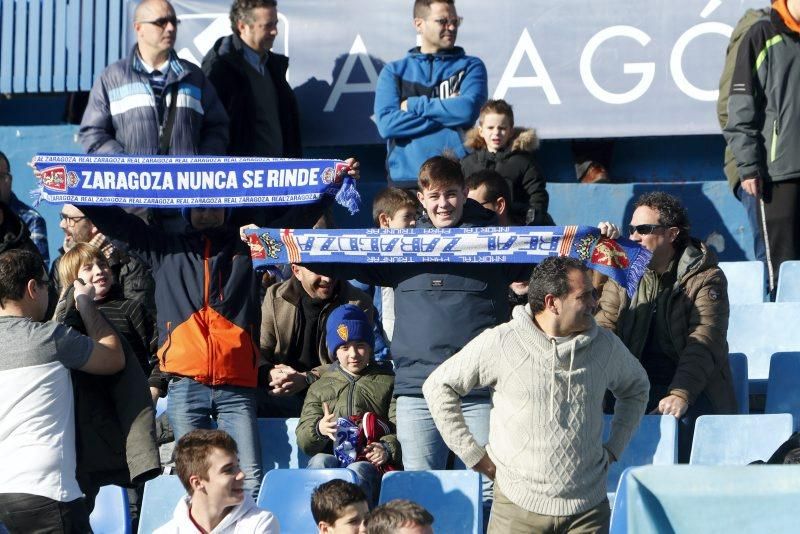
[0,493,92,534]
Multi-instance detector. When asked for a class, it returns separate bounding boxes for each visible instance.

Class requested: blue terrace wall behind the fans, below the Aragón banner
[0,126,753,261]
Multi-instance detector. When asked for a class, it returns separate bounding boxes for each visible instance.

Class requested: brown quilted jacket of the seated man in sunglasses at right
[595,240,736,414]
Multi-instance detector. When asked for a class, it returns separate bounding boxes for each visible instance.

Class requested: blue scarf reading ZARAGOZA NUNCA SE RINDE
[28,154,361,213]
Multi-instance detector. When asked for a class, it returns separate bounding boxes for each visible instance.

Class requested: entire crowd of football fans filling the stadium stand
[0,0,800,533]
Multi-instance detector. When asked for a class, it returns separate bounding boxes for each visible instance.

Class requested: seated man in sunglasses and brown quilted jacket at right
[596,191,736,462]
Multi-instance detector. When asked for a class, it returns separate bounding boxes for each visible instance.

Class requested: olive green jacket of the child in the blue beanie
[296,362,401,464]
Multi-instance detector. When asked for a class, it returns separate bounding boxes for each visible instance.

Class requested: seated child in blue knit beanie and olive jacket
[296,304,400,502]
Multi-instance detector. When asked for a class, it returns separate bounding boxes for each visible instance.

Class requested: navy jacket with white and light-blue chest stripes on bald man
[78,46,228,155]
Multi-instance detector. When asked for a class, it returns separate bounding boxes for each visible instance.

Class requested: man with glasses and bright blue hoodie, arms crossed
[375,0,488,188]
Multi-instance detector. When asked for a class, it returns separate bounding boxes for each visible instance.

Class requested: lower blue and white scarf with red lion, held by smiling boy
[245,226,651,295]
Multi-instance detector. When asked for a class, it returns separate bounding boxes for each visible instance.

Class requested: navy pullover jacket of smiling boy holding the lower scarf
[309,200,532,396]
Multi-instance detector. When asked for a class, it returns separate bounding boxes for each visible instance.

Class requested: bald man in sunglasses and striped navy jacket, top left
[79,0,228,155]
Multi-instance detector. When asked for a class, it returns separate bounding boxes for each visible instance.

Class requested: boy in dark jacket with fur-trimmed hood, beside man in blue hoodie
[461,100,554,226]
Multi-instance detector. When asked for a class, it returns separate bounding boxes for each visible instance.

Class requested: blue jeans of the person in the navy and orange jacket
[167,378,261,499]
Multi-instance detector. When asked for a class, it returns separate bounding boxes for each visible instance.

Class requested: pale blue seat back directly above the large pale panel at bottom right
[689,413,792,465]
